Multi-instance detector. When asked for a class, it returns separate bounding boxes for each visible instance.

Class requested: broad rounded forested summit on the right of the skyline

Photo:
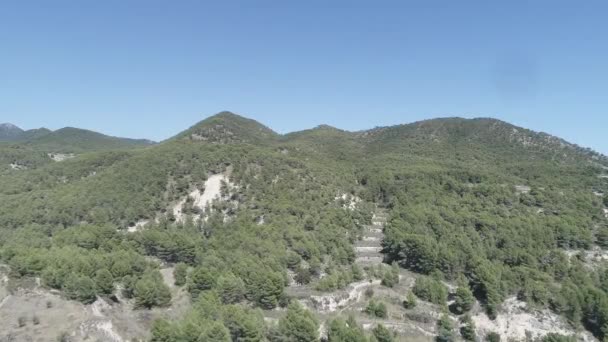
[358,118,605,162]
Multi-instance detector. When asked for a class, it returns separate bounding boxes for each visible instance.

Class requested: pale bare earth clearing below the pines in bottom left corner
[0,268,190,342]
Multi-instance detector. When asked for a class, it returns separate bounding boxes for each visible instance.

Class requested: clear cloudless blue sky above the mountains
[0,0,608,154]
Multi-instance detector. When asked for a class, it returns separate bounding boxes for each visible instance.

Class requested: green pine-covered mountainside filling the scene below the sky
[0,112,608,342]
